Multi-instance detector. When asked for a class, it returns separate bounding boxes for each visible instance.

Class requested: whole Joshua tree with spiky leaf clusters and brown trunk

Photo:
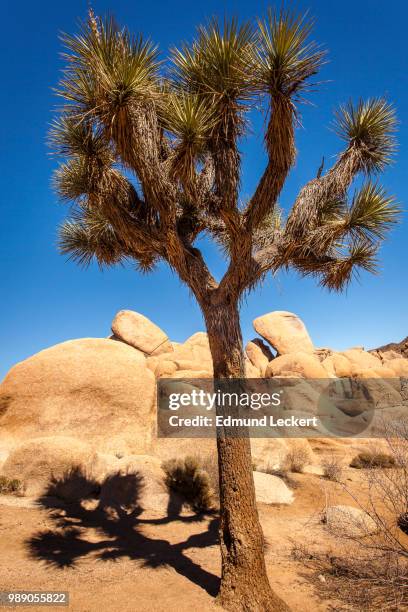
[51,11,398,612]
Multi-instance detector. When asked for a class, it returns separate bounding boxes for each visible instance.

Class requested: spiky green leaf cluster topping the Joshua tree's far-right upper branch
[335,98,397,172]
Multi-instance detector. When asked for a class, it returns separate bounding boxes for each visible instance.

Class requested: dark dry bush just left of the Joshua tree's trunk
[162,456,214,512]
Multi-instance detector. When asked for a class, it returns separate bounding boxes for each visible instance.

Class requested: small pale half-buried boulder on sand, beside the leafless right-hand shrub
[322,505,378,538]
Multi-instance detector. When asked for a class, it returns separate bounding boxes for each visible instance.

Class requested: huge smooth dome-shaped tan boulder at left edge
[0,338,155,454]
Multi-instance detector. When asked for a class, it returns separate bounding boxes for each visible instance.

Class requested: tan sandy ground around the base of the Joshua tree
[0,441,392,612]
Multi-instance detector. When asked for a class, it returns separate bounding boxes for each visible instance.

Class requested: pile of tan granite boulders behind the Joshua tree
[0,310,408,511]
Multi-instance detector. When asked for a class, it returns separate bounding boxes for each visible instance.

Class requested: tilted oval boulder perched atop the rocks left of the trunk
[112,310,173,355]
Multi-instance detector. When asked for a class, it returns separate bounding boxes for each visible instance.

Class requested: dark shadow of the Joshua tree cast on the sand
[26,469,219,596]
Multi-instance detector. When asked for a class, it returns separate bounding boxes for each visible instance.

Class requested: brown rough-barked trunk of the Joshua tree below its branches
[204,304,289,612]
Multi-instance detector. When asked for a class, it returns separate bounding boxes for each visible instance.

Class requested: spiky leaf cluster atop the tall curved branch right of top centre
[254,9,325,97]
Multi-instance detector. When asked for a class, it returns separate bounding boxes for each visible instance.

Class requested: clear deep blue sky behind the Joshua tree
[0,0,408,378]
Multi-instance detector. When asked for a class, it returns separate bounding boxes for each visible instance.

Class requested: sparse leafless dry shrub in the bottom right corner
[293,420,408,612]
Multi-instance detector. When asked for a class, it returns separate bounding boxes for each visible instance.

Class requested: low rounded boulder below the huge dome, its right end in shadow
[2,436,97,500]
